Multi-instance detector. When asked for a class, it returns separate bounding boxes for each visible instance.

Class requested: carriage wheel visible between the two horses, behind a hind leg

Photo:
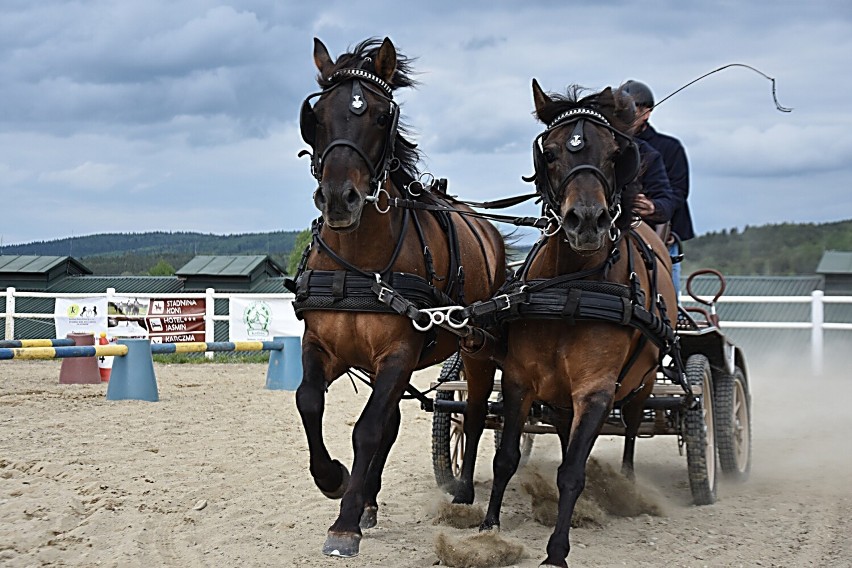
[432,353,467,493]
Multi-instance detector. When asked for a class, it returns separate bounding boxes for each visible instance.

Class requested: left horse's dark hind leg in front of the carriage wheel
[453,358,496,505]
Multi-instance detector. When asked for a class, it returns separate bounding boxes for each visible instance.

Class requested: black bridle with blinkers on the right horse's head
[525,107,640,240]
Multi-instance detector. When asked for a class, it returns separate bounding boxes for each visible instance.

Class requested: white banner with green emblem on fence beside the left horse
[228,297,305,341]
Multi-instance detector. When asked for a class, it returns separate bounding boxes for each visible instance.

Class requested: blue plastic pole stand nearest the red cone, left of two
[107,338,160,402]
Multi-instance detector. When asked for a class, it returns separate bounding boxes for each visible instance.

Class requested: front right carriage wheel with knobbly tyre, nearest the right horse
[684,355,717,505]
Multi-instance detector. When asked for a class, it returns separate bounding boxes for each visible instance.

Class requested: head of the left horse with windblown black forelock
[300,38,413,232]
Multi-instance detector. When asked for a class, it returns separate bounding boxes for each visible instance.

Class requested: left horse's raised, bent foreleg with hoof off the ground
[296,343,349,499]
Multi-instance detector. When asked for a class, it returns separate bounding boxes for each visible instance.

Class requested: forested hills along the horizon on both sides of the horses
[0,220,852,276]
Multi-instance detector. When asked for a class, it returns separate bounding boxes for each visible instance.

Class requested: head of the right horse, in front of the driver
[532,79,639,255]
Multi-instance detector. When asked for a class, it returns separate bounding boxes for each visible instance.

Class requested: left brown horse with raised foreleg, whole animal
[295,38,506,556]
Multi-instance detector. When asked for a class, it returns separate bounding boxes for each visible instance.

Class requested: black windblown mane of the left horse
[317,37,421,179]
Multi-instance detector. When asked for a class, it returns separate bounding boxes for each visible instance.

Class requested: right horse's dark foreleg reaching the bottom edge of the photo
[542,391,613,568]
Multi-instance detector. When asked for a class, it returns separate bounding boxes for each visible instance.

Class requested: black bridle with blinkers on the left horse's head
[299,66,399,199]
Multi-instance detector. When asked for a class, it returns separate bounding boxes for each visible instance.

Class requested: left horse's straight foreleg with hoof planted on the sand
[322,353,414,557]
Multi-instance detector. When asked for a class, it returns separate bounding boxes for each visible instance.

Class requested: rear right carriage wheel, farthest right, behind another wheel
[713,367,751,481]
